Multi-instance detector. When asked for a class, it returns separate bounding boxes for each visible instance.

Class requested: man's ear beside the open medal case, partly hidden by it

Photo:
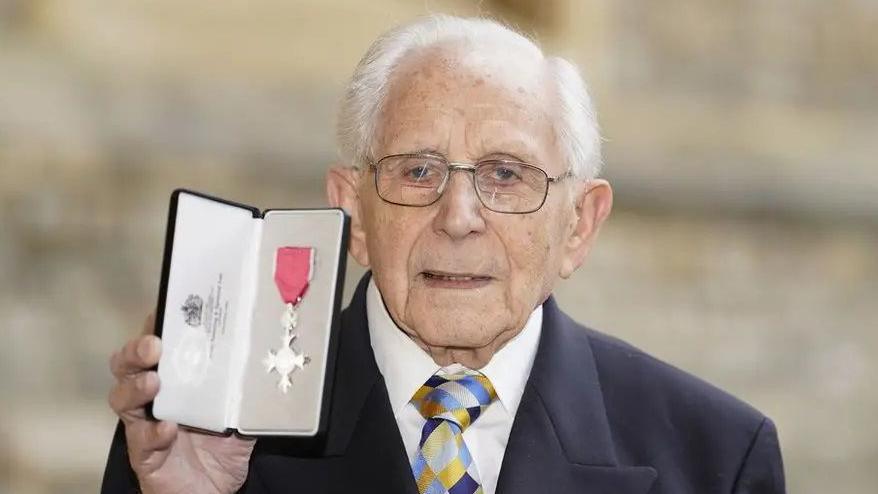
[326,166,369,267]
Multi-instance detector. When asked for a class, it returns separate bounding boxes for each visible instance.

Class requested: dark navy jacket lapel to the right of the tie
[497,297,657,494]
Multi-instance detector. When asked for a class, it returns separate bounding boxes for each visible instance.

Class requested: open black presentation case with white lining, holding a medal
[147,189,349,436]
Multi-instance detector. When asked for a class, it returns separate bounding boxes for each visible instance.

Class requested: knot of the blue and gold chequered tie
[412,372,497,430]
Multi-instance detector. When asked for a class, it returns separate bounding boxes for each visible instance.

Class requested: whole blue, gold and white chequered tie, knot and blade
[412,373,497,494]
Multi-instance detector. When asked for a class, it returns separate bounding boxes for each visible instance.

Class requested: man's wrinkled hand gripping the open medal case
[109,315,256,494]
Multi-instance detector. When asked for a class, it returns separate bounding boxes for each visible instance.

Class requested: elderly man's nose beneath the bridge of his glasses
[434,170,485,238]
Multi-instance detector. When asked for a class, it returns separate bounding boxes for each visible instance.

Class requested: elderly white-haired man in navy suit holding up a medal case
[104,16,784,494]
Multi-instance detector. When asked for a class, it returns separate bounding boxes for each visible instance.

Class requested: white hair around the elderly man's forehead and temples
[337,14,602,179]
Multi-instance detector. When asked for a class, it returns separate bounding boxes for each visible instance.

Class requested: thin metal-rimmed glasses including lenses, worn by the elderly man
[369,153,573,214]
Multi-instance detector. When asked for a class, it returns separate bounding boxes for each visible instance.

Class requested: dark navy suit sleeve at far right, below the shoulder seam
[732,418,786,494]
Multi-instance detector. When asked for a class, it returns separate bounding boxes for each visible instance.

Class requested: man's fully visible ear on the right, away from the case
[559,179,613,278]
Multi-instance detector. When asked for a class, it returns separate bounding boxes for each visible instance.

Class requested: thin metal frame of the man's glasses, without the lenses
[369,153,573,214]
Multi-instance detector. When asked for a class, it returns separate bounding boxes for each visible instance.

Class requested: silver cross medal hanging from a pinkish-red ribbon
[262,247,314,394]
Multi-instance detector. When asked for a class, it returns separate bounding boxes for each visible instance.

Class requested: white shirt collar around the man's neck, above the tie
[366,279,543,416]
